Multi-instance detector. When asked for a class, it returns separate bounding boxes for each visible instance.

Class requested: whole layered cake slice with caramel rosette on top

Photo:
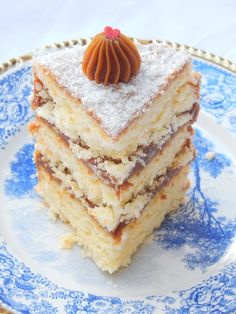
[30,27,200,273]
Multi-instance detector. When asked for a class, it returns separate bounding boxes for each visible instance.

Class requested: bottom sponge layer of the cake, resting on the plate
[37,159,189,273]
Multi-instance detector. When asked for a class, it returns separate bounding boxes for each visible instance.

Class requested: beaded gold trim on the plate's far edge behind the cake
[0,38,236,74]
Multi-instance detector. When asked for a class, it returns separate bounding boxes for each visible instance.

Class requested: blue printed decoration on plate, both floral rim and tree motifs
[0,60,236,314]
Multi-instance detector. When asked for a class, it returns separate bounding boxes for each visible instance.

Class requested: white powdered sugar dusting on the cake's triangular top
[34,43,190,138]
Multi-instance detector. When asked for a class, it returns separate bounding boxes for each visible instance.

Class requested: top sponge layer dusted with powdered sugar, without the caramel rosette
[32,43,199,160]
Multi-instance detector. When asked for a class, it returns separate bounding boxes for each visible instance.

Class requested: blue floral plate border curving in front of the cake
[0,242,236,314]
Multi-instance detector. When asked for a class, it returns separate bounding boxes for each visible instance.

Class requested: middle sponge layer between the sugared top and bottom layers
[32,116,194,206]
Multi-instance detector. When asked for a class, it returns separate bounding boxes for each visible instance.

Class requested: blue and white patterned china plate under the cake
[0,48,236,314]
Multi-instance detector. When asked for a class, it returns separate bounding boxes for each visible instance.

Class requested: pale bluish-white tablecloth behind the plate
[0,0,236,62]
